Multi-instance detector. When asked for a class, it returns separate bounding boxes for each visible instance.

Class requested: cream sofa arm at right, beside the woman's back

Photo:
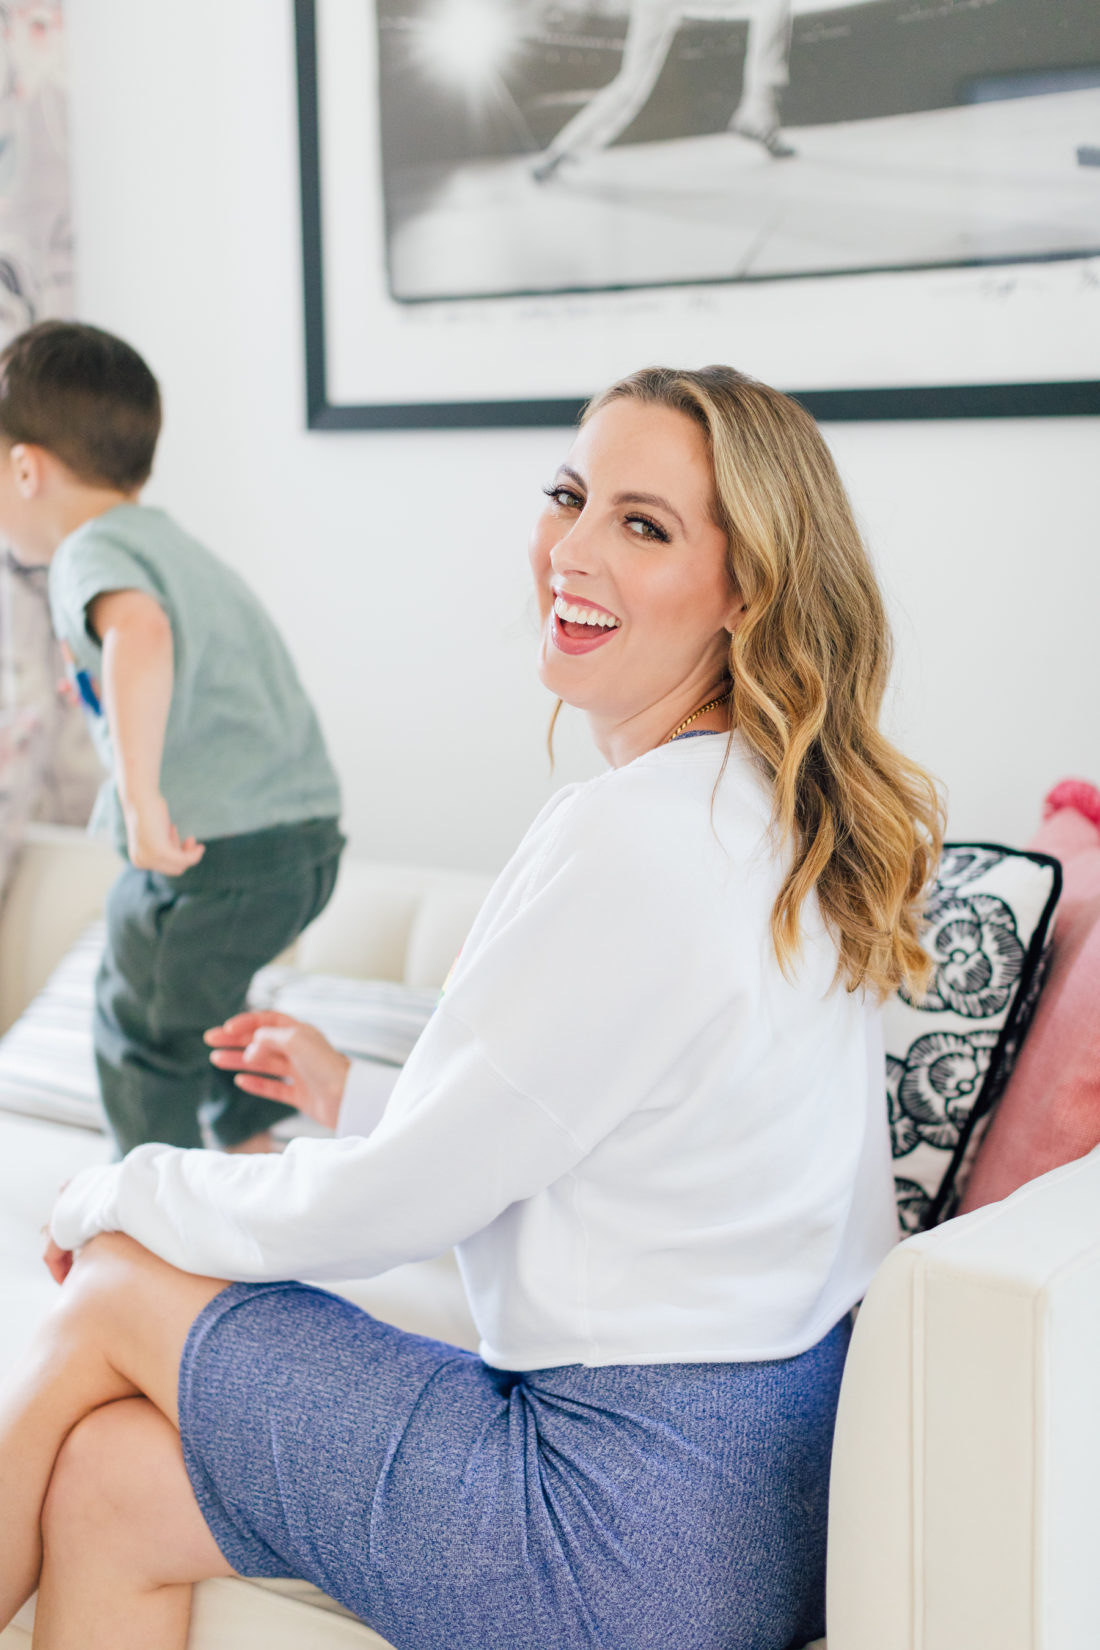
[828,1150,1100,1650]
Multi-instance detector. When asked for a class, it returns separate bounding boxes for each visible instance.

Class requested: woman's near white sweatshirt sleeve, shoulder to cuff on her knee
[53,765,755,1282]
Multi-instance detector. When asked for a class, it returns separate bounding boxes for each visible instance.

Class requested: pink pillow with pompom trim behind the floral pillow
[958,780,1100,1214]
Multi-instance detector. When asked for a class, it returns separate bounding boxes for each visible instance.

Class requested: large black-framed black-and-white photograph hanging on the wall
[295,0,1100,429]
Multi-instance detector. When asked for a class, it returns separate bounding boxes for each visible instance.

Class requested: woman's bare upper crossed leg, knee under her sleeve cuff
[0,1234,224,1627]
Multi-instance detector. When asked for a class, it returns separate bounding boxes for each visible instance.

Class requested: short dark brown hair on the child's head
[0,320,160,493]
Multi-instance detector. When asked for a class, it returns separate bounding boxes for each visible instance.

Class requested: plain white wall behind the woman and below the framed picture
[68,0,1100,868]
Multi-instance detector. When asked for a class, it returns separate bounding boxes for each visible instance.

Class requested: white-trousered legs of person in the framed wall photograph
[533,0,795,183]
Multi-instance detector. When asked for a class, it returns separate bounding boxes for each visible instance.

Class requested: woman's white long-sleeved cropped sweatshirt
[53,738,897,1370]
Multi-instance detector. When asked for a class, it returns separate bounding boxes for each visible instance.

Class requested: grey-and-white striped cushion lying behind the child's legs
[0,922,439,1129]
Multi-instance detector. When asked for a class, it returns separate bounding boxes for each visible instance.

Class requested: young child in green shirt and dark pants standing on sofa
[0,322,343,1152]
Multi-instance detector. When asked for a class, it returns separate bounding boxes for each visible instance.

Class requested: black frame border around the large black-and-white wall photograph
[294,0,1100,431]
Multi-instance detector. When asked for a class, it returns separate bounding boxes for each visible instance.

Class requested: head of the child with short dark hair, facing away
[0,320,160,561]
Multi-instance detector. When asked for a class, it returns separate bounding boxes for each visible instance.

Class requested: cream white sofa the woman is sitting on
[0,828,1100,1650]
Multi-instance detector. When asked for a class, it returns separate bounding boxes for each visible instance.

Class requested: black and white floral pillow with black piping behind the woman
[884,843,1062,1233]
